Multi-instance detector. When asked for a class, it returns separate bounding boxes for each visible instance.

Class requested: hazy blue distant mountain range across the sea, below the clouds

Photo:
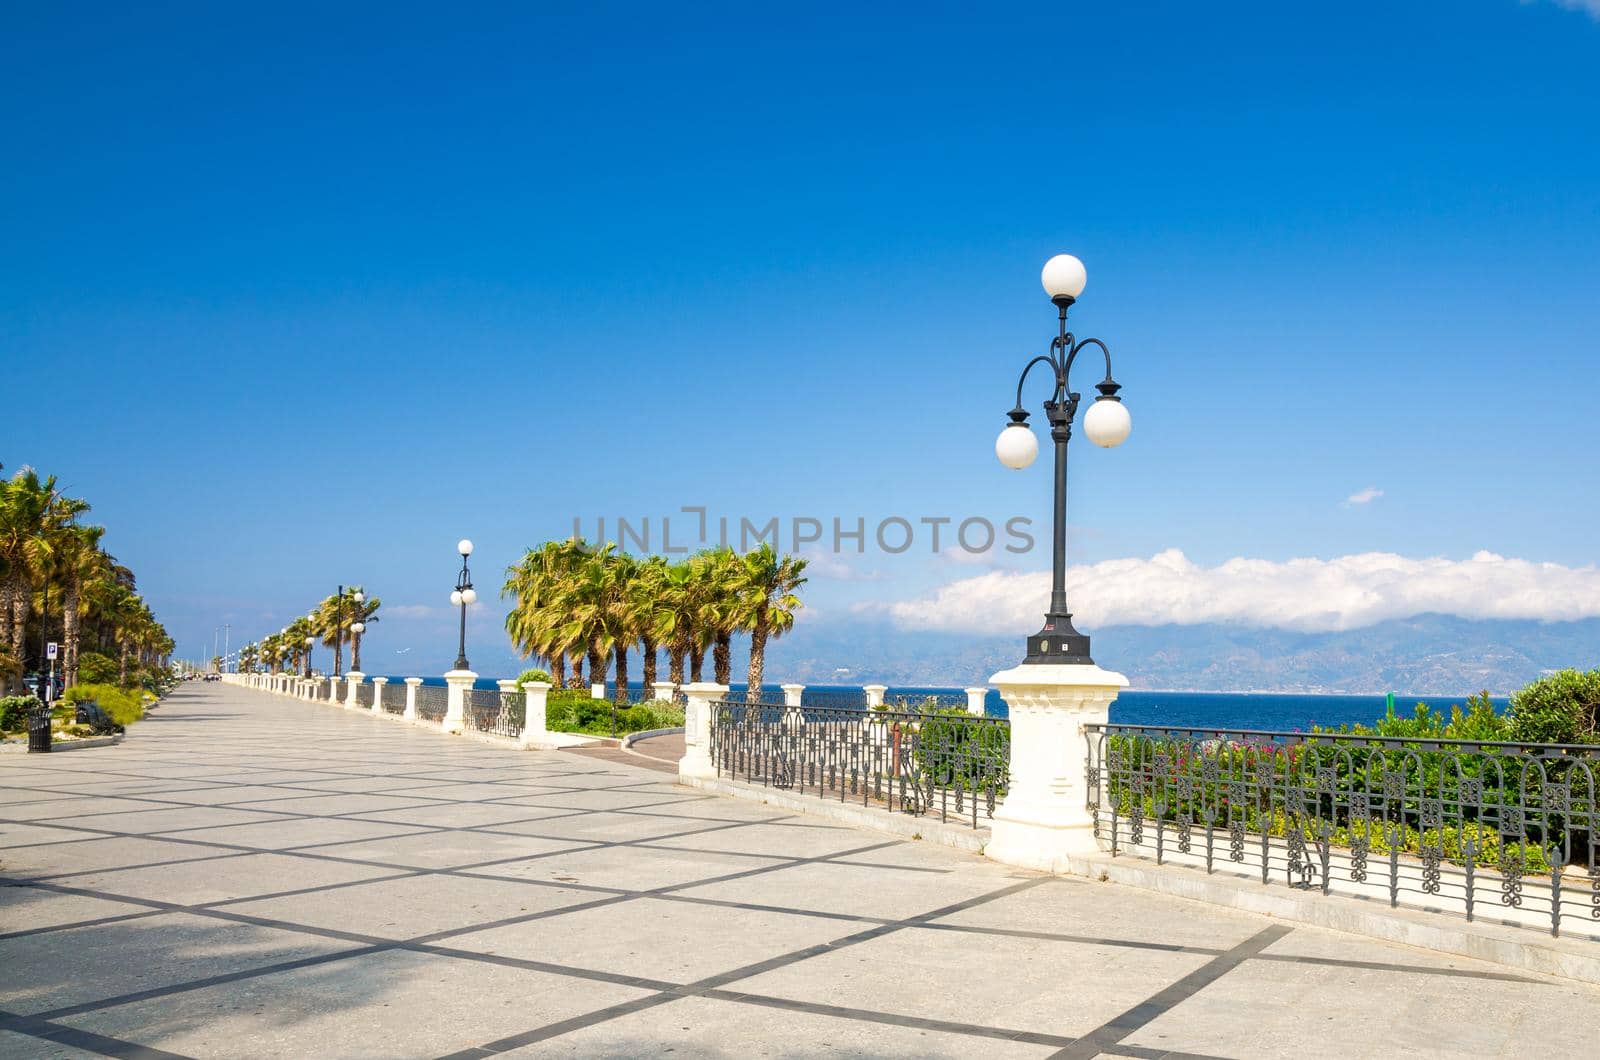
[766,613,1600,695]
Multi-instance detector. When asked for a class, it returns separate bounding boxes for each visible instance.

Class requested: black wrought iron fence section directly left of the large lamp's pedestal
[710,700,1011,828]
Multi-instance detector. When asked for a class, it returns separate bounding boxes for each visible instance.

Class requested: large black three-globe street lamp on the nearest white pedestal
[995,255,1133,665]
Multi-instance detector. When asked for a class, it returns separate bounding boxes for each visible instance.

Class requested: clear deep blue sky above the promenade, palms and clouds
[0,0,1600,671]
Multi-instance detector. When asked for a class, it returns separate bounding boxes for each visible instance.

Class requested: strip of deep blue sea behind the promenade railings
[380,677,1507,732]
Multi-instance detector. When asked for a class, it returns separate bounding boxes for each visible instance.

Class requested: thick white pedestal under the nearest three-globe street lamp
[984,663,1128,873]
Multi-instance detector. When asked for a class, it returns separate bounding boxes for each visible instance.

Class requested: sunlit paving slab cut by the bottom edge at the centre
[506,998,1054,1060]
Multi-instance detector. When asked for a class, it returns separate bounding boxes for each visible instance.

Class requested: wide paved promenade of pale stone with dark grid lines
[0,684,1600,1060]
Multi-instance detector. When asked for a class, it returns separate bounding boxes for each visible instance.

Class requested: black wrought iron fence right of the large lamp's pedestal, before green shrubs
[1086,725,1600,935]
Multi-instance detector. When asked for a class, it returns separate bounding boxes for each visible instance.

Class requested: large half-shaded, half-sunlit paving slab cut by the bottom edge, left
[62,951,645,1060]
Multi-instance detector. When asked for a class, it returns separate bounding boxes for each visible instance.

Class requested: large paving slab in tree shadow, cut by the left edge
[0,913,352,1014]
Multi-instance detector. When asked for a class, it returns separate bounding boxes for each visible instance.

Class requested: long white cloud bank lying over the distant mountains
[874,549,1600,632]
